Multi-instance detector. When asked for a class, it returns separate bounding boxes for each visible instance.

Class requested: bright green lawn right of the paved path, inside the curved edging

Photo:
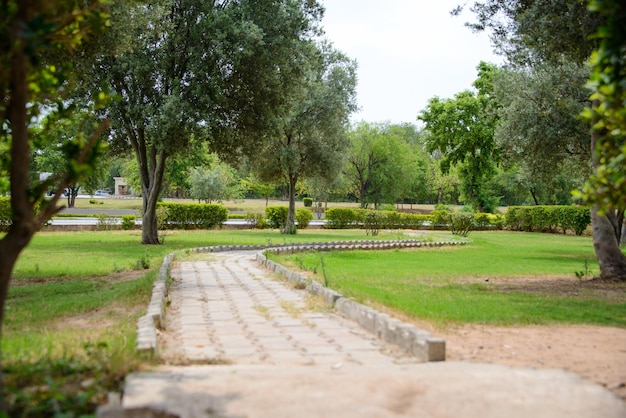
[270,232,626,327]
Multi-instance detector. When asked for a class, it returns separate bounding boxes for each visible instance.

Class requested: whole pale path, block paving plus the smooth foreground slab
[112,251,626,418]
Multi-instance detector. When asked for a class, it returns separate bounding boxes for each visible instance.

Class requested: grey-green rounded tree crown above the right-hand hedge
[494,61,591,188]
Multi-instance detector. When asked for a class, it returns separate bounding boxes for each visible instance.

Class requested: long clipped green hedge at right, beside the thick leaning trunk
[505,206,591,235]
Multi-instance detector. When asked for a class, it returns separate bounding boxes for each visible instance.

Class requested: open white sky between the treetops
[321,0,502,123]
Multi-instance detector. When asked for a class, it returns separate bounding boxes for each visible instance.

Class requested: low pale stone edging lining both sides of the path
[137,240,466,361]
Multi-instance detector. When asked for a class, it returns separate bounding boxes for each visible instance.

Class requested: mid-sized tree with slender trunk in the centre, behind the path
[254,42,356,233]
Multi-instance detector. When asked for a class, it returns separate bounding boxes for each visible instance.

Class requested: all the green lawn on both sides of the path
[2,229,626,416]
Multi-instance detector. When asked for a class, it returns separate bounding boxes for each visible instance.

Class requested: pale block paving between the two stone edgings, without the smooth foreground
[167,251,416,367]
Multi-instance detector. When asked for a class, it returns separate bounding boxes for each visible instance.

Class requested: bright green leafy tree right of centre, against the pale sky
[418,62,498,212]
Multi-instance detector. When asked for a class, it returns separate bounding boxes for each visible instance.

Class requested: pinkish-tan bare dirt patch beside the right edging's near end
[433,325,626,400]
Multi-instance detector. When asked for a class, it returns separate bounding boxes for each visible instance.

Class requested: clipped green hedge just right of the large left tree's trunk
[157,202,228,229]
